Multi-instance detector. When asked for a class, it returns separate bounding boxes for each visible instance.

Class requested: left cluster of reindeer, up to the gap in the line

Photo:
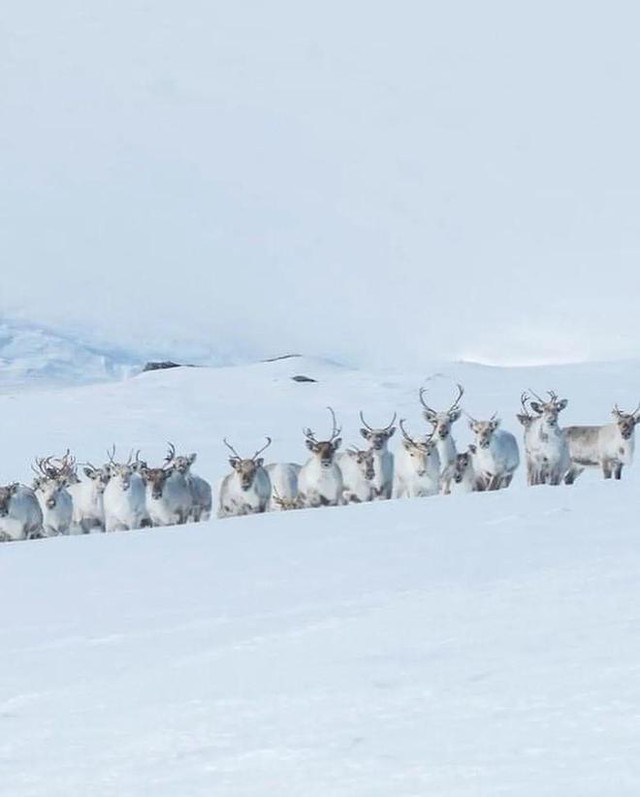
[0,443,212,541]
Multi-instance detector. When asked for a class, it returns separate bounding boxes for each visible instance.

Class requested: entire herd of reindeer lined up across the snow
[0,385,640,541]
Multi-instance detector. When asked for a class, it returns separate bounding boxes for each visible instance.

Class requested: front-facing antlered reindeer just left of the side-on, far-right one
[517,391,571,485]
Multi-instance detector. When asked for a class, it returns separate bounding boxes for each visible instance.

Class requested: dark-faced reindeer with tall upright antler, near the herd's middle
[298,407,344,507]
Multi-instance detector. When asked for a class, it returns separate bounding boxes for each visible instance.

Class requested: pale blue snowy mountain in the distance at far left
[0,319,144,391]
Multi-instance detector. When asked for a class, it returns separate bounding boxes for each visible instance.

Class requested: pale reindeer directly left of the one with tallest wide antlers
[393,419,440,498]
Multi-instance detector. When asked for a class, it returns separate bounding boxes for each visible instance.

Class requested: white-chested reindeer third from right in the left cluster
[103,445,149,531]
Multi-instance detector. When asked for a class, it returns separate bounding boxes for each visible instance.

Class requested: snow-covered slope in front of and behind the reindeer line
[0,358,640,797]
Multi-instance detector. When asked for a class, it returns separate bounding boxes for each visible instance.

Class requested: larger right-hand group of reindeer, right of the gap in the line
[218,385,640,518]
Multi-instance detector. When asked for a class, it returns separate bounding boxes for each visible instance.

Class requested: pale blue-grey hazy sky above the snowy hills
[0,0,640,363]
